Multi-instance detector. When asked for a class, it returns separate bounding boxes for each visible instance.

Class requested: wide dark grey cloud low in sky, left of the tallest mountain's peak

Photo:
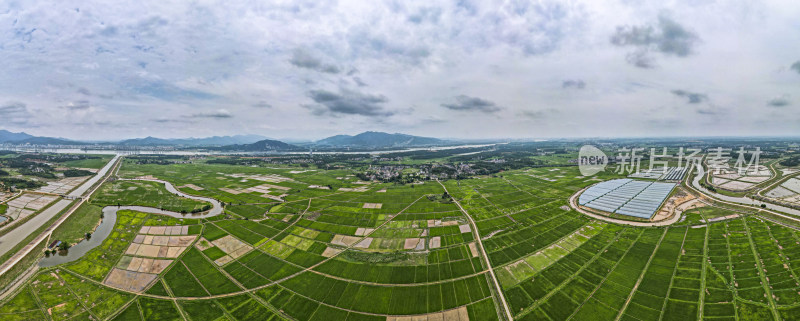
[304,89,394,117]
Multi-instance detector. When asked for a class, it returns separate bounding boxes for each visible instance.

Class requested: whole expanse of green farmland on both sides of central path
[0,156,800,320]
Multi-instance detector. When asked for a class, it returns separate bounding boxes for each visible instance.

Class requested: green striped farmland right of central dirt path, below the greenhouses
[448,169,800,320]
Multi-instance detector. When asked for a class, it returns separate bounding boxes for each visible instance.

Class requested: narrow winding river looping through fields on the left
[39,179,223,267]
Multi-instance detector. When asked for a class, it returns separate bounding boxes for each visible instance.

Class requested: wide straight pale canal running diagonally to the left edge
[0,156,119,255]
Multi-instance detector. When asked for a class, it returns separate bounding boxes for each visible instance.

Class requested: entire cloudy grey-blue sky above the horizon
[0,0,800,140]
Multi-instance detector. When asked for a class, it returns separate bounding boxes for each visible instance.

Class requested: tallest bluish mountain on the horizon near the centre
[314,132,448,148]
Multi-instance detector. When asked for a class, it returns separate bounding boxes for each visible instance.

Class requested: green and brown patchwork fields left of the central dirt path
[0,160,498,320]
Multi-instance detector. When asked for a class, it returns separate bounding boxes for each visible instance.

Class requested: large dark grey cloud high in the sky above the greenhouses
[611,15,700,68]
